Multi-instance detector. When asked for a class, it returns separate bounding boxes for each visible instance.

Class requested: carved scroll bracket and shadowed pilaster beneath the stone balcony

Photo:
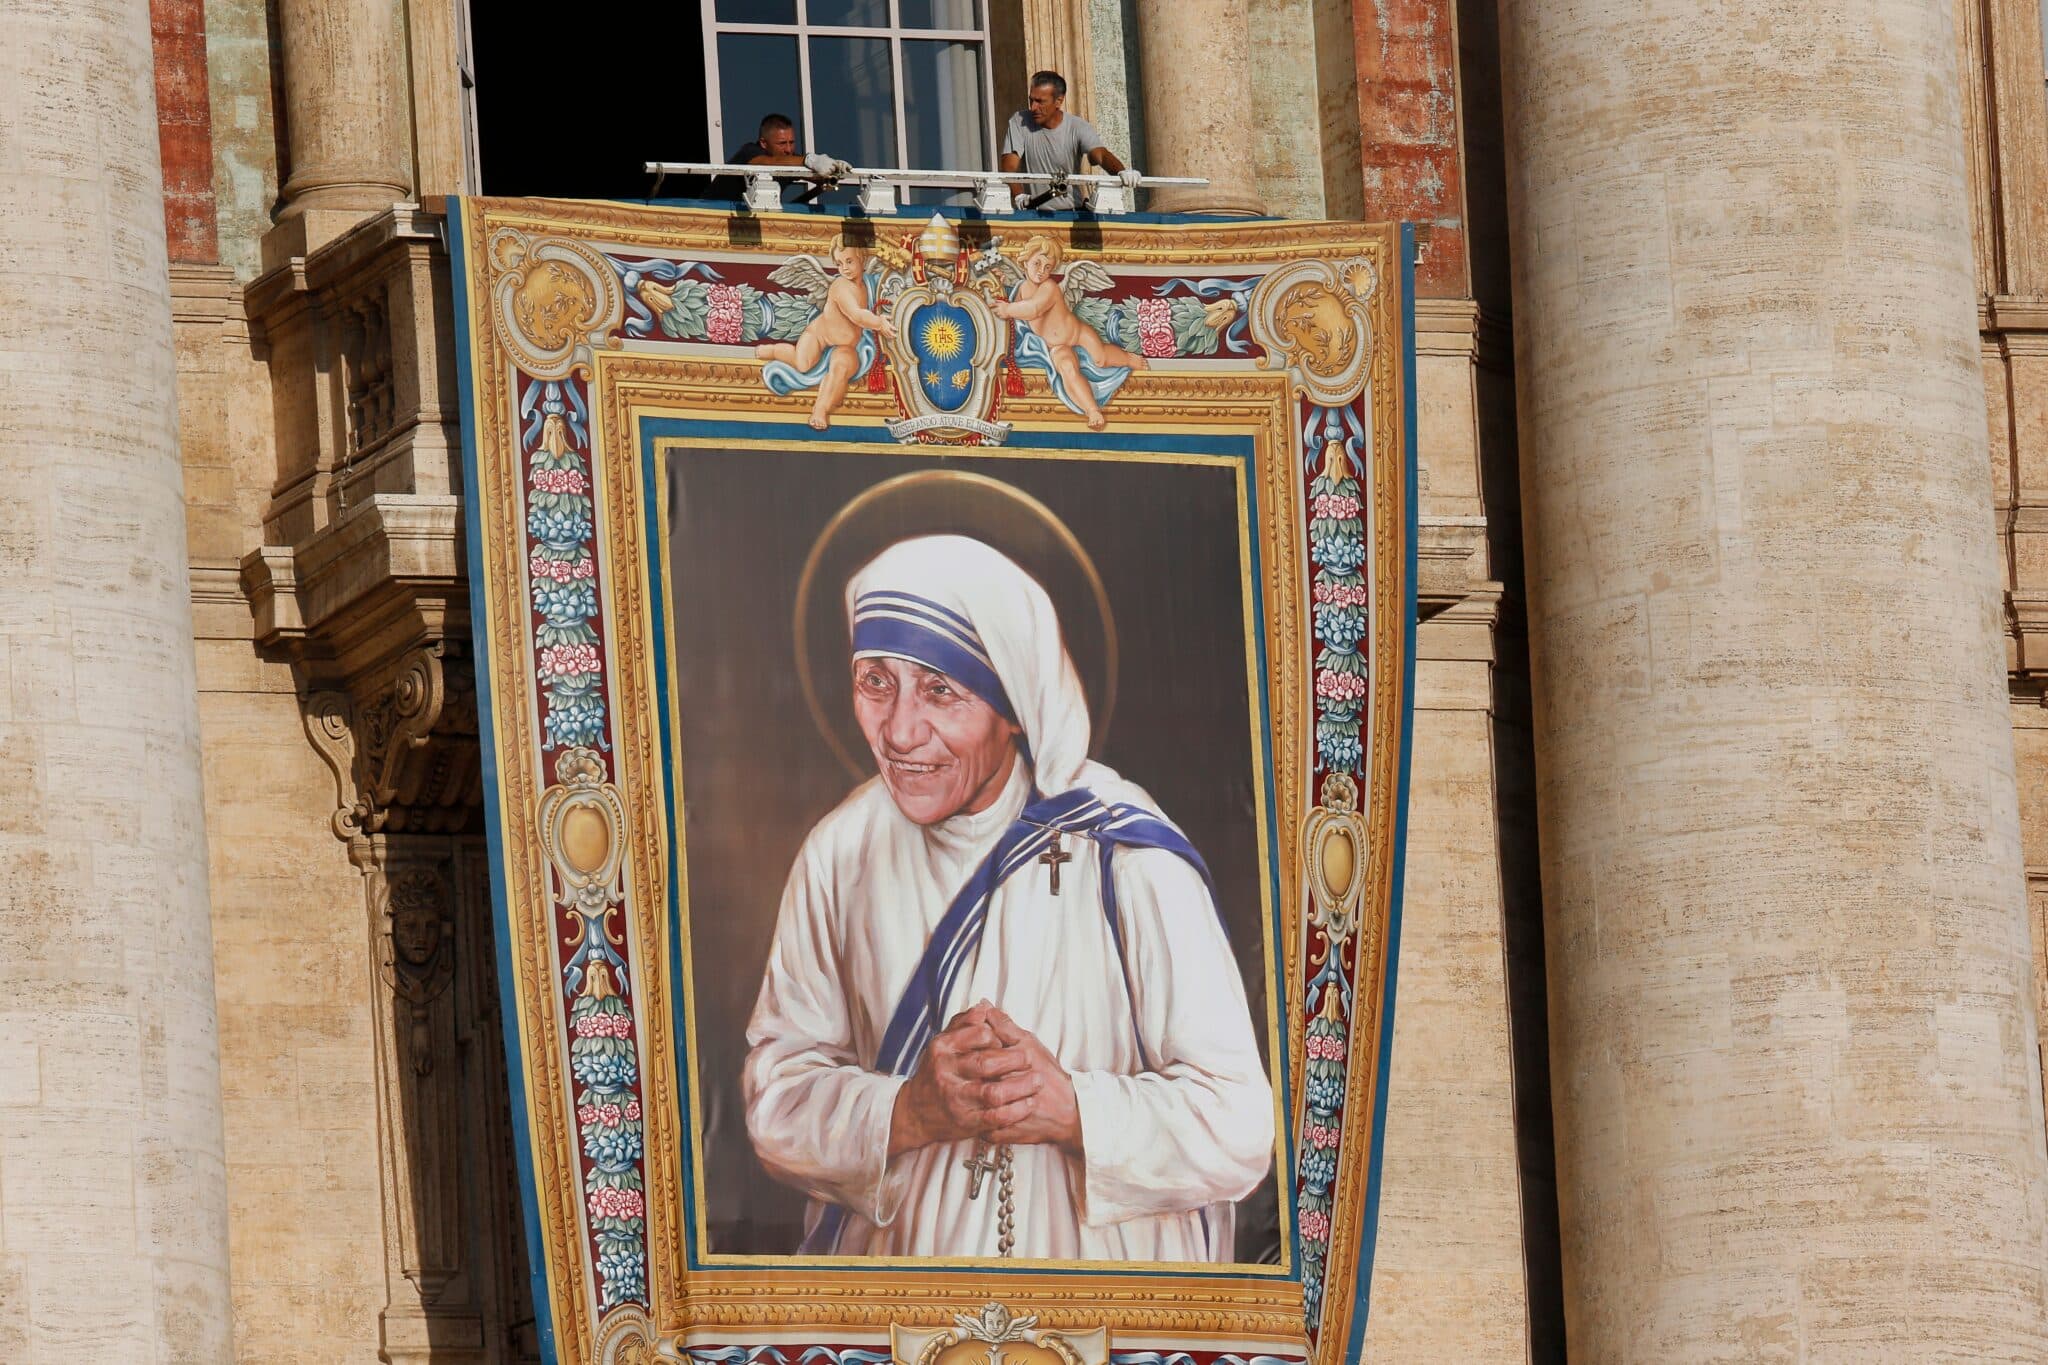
[305,641,532,1365]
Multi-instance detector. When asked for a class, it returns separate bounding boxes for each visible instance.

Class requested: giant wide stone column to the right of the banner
[1501,0,2048,1361]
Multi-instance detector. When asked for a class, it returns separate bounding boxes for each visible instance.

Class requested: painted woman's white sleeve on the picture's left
[743,843,903,1224]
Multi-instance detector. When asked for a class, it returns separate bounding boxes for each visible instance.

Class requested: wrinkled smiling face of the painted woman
[854,659,1018,825]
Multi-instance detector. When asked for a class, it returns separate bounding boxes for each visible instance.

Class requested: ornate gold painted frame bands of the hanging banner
[451,199,1413,1365]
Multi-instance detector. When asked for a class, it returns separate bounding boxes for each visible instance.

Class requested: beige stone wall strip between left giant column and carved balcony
[174,270,385,1365]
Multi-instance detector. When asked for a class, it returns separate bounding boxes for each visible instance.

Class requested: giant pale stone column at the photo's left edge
[0,0,231,1365]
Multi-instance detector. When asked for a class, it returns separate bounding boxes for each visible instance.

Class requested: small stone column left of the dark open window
[276,0,412,217]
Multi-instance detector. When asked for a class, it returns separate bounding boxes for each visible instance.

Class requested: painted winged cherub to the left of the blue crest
[754,233,901,432]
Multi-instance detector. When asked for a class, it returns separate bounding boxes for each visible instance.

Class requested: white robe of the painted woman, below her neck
[745,763,1274,1261]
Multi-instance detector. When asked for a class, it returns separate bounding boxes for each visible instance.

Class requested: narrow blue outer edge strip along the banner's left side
[444,194,555,1365]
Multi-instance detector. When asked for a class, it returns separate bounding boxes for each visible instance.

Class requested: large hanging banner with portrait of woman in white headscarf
[451,199,1415,1365]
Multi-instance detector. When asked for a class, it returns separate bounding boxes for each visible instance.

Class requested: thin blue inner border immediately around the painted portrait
[635,417,1300,1283]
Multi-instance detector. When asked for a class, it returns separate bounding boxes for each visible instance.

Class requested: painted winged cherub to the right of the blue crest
[975,235,1147,432]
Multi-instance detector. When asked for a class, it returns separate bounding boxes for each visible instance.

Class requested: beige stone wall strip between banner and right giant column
[1366,301,1530,1365]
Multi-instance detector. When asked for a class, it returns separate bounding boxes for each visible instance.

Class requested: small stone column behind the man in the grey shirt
[1139,0,1266,215]
